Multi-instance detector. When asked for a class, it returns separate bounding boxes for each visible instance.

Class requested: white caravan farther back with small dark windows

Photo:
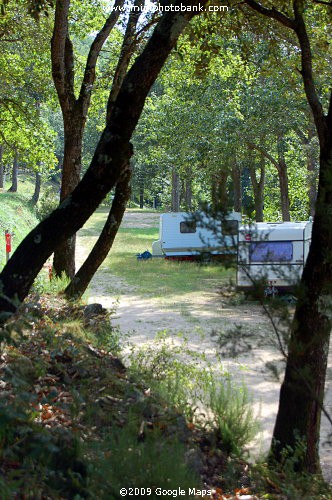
[152,212,241,258]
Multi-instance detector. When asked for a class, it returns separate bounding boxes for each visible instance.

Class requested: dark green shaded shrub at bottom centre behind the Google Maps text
[86,414,200,499]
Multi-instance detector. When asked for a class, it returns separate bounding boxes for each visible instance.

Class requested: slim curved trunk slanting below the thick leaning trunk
[65,170,131,299]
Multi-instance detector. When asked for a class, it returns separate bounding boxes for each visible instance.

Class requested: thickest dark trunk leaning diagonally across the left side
[0,0,206,321]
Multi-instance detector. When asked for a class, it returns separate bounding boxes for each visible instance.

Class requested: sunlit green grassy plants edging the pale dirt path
[131,334,258,456]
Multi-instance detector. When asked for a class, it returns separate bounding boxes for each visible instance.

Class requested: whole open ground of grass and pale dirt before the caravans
[78,210,332,480]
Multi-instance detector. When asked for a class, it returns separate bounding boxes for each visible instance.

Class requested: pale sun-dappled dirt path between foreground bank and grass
[78,209,332,481]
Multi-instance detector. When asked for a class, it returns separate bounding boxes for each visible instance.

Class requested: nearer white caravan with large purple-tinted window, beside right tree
[237,221,312,290]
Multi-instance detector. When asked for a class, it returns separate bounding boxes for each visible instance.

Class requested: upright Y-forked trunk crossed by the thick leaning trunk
[51,0,124,277]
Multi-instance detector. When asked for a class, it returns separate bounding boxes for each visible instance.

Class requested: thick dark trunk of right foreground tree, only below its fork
[271,138,332,473]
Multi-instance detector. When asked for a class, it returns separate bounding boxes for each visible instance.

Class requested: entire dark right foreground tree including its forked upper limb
[246,0,332,473]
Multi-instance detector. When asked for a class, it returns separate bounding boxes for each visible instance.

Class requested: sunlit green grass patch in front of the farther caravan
[80,209,233,298]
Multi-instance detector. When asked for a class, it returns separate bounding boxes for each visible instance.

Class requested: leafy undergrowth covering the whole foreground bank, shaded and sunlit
[0,294,329,500]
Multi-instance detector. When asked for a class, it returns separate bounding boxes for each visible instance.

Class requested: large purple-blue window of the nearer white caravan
[249,241,293,262]
